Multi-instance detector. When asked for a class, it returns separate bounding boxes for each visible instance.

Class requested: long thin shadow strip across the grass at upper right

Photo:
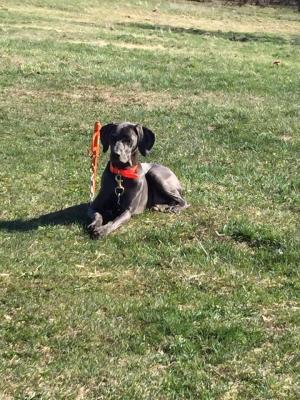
[118,22,300,45]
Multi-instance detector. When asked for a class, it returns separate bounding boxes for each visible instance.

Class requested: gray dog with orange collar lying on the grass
[88,122,188,239]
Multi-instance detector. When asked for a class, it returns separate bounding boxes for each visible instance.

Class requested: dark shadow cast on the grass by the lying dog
[0,203,88,232]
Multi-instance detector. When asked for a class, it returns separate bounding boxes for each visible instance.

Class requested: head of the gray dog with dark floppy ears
[100,122,155,168]
